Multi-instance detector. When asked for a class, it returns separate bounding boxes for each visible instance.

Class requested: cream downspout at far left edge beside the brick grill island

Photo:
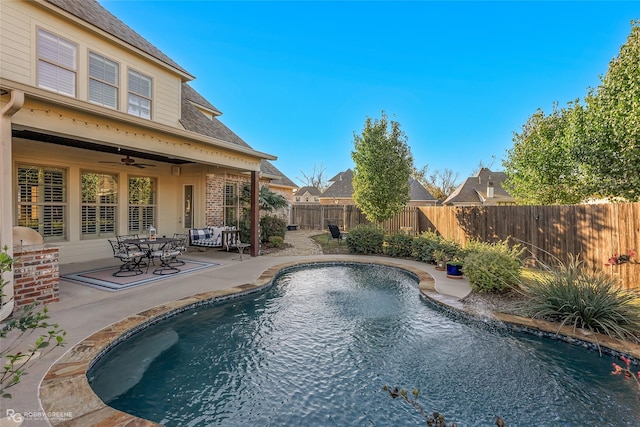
[0,90,24,320]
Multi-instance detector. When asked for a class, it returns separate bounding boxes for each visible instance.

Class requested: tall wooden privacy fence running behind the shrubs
[292,203,640,288]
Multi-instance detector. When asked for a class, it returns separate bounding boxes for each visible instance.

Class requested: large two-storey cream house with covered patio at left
[0,0,296,263]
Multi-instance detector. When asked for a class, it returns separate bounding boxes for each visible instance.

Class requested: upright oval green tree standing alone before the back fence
[351,111,413,222]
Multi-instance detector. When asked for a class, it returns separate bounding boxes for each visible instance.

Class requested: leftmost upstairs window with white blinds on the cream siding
[38,29,78,97]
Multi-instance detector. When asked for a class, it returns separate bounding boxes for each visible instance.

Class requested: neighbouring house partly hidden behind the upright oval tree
[320,169,438,206]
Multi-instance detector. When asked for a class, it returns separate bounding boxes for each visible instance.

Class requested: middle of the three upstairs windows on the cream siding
[89,52,118,109]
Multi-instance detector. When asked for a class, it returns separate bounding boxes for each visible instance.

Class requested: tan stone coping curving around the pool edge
[39,257,640,427]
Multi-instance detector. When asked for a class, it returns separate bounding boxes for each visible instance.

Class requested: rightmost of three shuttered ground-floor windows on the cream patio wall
[129,177,157,234]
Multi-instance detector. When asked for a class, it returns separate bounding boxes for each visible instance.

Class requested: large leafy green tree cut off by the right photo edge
[579,20,640,201]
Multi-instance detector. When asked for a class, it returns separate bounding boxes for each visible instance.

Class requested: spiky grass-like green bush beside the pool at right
[521,258,640,343]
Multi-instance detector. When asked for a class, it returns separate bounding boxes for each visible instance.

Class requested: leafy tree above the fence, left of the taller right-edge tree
[503,101,587,205]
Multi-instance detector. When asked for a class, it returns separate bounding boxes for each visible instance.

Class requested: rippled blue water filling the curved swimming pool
[88,265,640,427]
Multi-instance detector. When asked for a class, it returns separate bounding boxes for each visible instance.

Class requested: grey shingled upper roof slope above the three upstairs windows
[46,0,193,80]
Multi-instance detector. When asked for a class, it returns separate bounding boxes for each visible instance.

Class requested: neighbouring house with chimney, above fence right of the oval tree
[442,168,515,206]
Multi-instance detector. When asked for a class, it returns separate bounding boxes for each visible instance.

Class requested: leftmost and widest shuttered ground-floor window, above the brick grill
[16,166,67,241]
